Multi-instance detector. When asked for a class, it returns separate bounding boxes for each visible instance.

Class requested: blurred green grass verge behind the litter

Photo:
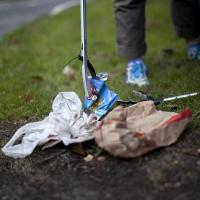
[0,0,200,125]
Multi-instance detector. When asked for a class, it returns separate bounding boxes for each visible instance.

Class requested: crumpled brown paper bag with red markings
[95,101,192,158]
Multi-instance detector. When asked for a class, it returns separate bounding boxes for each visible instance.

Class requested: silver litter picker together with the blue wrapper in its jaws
[79,0,118,118]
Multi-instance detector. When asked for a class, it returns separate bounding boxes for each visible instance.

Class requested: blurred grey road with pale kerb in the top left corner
[0,0,79,36]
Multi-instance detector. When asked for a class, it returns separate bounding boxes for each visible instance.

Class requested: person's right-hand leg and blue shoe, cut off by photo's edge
[171,0,200,60]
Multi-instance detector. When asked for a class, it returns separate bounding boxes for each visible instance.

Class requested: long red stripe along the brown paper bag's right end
[161,108,192,128]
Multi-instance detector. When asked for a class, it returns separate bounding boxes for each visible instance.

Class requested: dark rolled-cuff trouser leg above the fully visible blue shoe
[114,0,146,60]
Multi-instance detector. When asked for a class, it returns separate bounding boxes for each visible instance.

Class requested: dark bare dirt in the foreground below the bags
[0,123,200,200]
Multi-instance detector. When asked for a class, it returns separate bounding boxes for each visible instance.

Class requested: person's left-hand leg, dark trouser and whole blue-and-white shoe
[114,0,148,86]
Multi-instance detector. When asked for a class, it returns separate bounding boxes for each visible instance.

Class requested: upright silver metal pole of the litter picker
[80,0,88,96]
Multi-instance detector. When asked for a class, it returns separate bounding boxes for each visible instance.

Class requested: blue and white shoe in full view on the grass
[126,59,149,87]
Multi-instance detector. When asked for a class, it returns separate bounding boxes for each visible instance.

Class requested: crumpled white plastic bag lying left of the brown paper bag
[2,92,97,158]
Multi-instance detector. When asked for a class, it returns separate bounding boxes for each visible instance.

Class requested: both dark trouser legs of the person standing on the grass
[114,0,200,59]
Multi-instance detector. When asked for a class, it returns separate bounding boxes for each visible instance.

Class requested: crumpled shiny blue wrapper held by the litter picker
[84,79,119,118]
